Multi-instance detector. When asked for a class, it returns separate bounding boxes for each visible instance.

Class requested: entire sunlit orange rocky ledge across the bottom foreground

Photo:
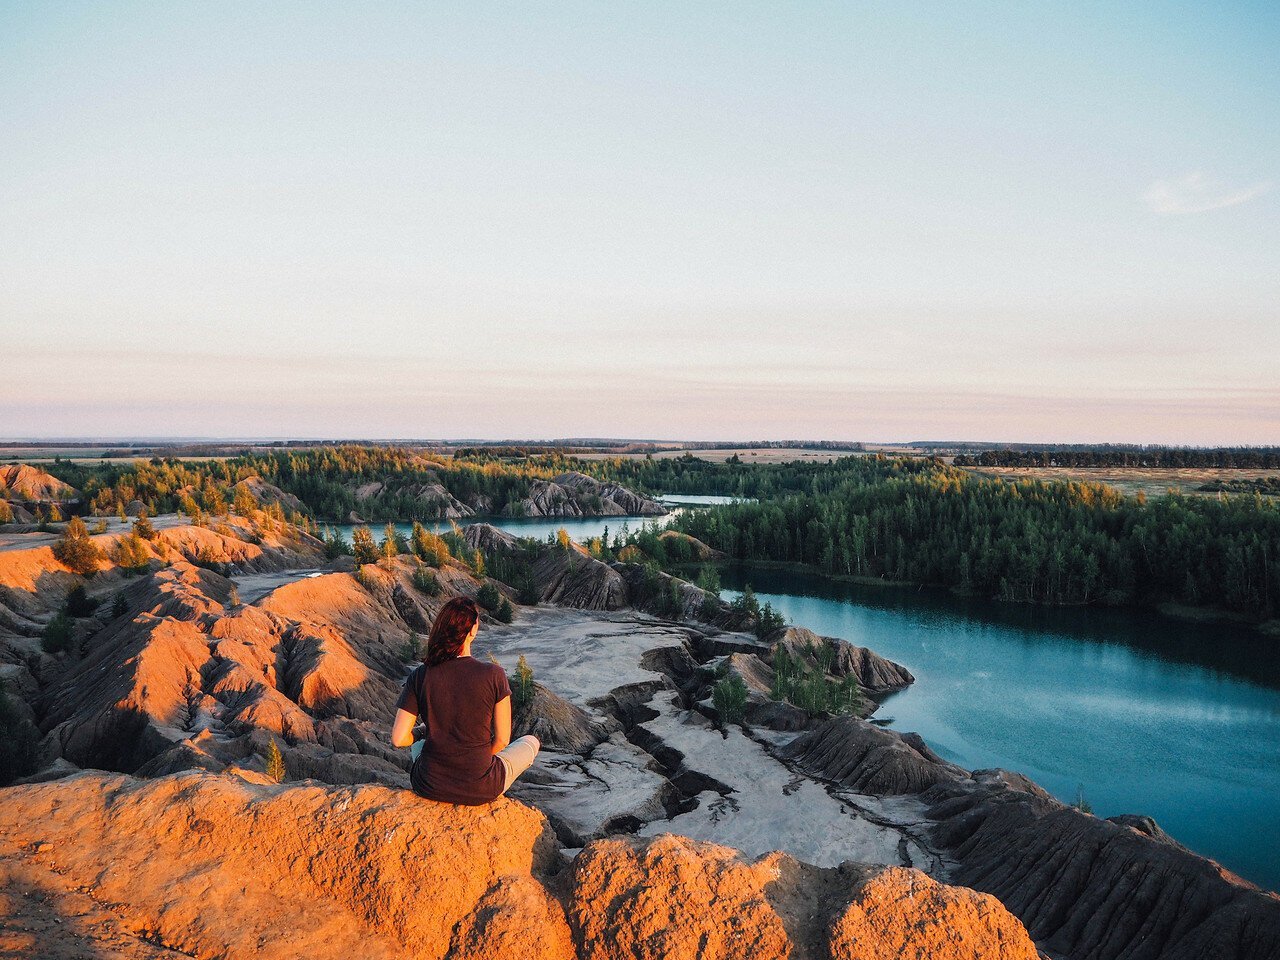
[0,772,1037,960]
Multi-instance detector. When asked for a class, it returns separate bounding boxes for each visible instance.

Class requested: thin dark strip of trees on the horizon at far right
[952,447,1280,470]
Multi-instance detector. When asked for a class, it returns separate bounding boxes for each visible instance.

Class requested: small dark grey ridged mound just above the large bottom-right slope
[780,717,969,796]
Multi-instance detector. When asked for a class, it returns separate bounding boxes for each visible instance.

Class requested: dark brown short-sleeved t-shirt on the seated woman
[396,657,511,805]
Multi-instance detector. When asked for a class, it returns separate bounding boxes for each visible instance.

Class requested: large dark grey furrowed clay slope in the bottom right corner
[924,777,1280,960]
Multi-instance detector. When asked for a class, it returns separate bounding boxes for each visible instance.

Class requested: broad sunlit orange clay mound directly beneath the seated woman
[0,773,573,960]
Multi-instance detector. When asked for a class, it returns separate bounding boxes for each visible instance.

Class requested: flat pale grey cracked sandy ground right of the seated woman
[476,608,945,874]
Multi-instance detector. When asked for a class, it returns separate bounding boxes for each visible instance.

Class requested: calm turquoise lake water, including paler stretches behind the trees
[337,506,1280,890]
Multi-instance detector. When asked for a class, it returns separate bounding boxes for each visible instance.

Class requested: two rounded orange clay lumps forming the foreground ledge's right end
[570,835,1038,960]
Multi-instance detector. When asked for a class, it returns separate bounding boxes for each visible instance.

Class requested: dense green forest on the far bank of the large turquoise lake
[675,458,1280,618]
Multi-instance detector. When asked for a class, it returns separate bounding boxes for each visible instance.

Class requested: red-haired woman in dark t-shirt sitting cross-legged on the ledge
[392,596,541,805]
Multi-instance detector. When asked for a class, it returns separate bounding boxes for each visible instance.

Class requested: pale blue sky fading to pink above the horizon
[0,1,1280,443]
